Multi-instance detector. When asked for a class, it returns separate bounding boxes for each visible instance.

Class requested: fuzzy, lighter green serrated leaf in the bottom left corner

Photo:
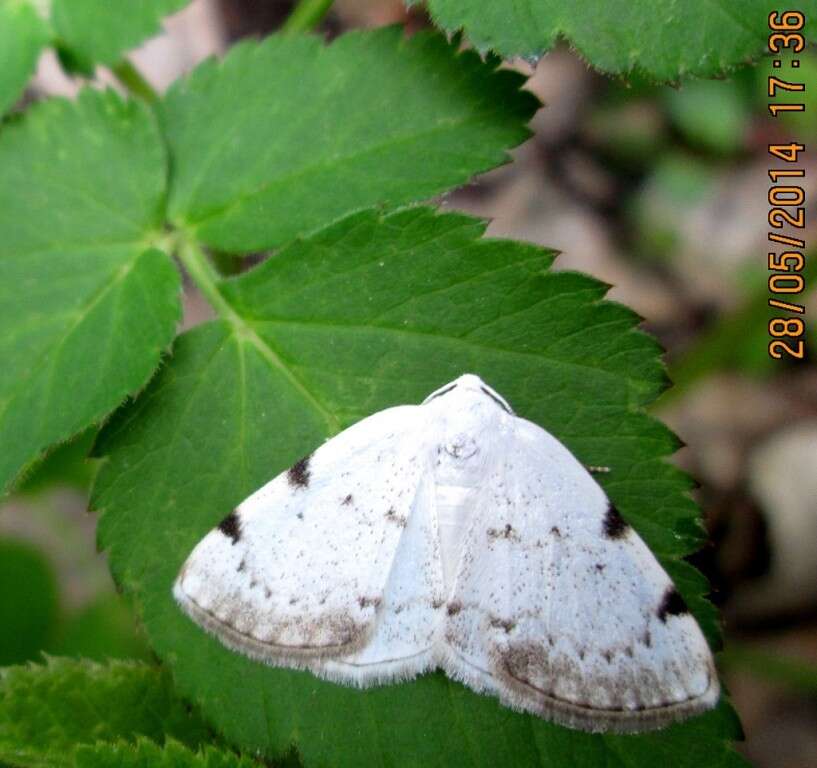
[0,659,211,766]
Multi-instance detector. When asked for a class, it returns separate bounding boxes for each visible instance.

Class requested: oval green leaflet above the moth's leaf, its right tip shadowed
[161,27,537,252]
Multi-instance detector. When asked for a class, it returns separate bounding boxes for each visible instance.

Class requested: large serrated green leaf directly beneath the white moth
[92,208,737,768]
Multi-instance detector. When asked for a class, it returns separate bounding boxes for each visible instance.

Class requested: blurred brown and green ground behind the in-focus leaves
[0,0,817,768]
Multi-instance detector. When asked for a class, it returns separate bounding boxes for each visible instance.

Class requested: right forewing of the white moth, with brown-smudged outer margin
[445,419,719,732]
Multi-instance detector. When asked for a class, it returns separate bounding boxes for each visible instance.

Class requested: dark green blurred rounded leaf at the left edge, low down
[0,539,59,666]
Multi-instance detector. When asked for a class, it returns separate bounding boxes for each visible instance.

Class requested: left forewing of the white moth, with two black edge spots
[174,406,436,666]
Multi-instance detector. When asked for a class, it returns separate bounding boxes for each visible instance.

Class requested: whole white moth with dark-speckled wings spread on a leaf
[173,375,719,731]
